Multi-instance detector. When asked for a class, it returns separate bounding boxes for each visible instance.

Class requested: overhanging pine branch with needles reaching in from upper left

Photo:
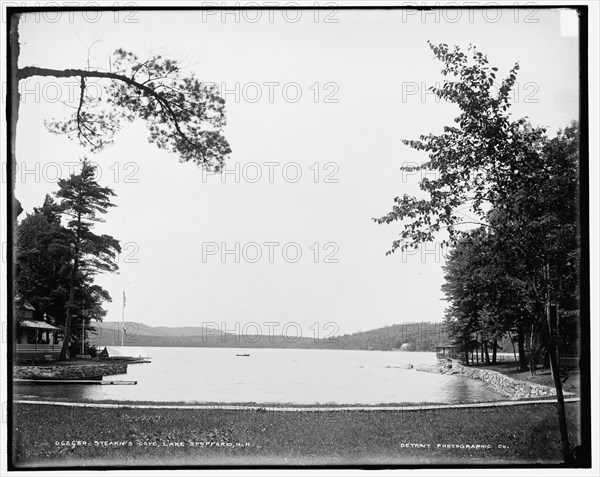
[18,49,231,171]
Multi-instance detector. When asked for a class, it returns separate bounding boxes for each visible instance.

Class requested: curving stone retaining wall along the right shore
[416,361,574,400]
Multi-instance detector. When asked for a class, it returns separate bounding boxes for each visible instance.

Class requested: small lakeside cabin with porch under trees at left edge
[15,302,63,361]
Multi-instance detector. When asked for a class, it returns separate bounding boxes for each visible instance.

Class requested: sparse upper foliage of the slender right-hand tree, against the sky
[374,44,544,253]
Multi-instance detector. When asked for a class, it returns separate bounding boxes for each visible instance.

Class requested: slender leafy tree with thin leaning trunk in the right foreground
[375,44,577,460]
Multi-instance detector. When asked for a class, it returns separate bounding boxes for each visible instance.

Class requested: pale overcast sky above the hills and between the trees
[10,10,579,336]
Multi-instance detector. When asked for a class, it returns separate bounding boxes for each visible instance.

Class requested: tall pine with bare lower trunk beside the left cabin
[56,160,121,359]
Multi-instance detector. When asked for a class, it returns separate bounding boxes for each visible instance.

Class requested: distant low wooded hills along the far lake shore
[89,321,448,351]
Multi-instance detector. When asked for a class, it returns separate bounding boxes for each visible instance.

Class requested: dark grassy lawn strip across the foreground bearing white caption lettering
[13,403,580,467]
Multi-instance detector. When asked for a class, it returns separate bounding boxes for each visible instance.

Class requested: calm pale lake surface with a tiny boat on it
[14,348,504,404]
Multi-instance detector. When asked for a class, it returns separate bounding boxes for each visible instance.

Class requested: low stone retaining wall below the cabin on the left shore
[13,363,127,379]
